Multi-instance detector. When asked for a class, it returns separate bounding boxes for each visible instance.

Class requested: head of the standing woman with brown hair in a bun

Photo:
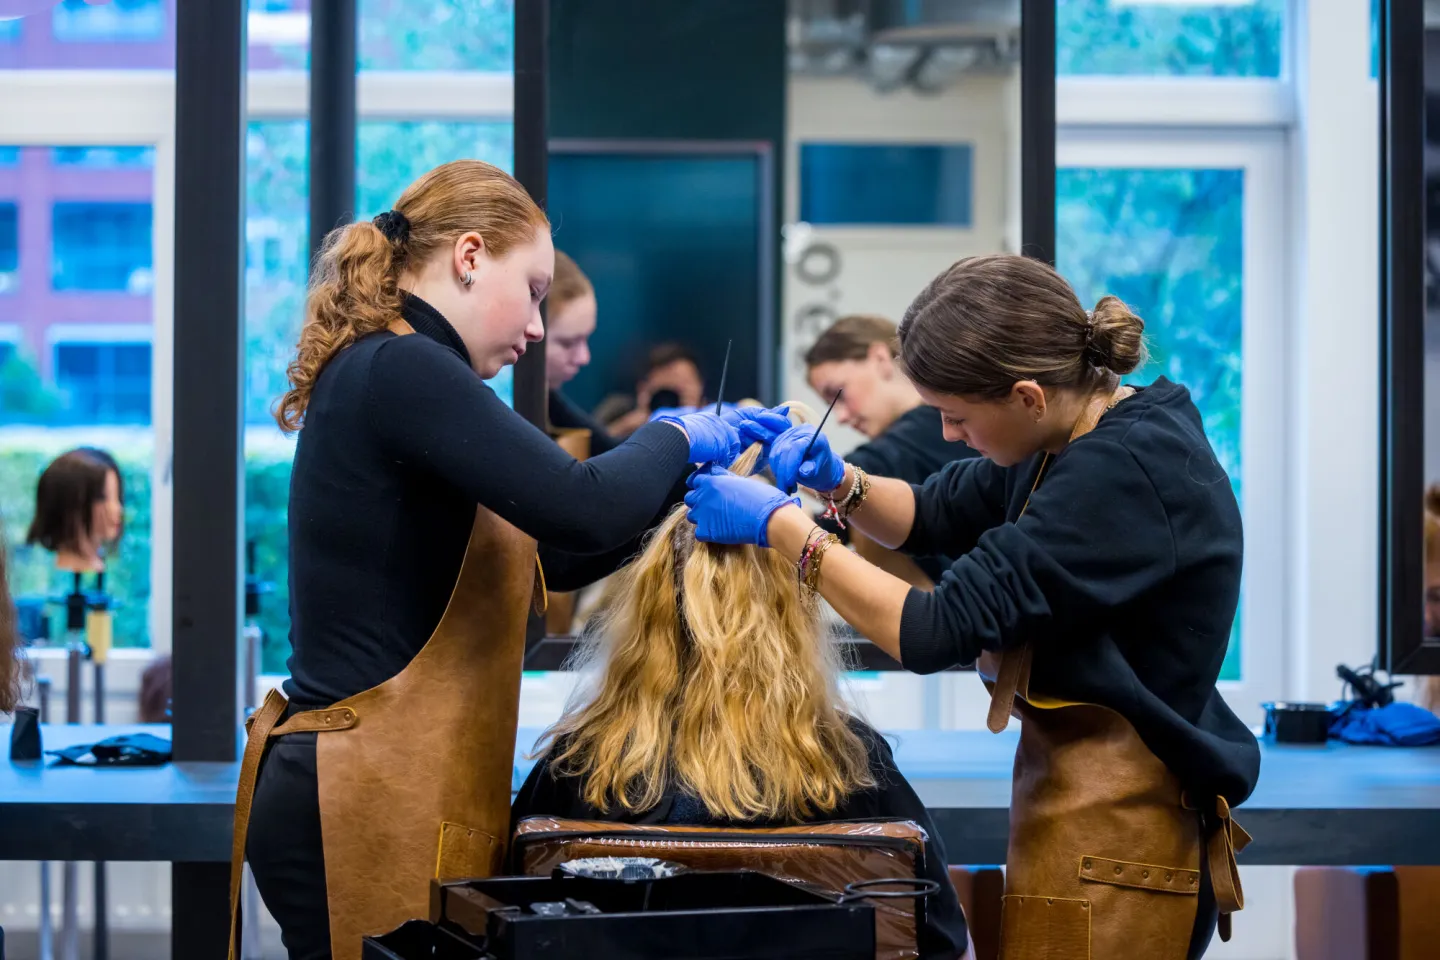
[899,255,1145,466]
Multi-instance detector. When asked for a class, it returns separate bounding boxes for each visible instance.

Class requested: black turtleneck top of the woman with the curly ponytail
[285,296,690,707]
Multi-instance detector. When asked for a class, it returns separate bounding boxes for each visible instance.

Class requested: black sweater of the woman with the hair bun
[900,379,1260,805]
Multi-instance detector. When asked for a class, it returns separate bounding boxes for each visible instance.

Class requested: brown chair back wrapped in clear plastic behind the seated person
[511,816,973,960]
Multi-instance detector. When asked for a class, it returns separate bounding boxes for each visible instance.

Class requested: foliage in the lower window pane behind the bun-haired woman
[1056,168,1244,679]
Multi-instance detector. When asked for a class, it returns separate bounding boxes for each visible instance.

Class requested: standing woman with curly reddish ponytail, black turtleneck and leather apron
[232,160,783,960]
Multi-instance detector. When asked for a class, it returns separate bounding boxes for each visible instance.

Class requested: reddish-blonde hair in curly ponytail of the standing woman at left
[275,160,549,432]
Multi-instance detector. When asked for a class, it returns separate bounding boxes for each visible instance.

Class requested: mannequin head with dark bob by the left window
[26,448,125,573]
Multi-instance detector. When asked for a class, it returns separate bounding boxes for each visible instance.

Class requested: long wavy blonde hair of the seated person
[541,408,876,822]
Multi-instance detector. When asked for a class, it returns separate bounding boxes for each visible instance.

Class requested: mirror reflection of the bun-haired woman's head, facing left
[805,314,920,439]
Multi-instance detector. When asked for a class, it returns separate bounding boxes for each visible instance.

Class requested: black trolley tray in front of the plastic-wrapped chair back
[361,871,876,960]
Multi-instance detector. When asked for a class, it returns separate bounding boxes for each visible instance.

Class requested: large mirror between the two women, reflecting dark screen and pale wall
[535,0,1021,679]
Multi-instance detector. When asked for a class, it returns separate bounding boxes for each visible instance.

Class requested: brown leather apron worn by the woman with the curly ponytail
[230,322,544,960]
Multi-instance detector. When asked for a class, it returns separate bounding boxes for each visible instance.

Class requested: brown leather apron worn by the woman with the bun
[978,385,1250,960]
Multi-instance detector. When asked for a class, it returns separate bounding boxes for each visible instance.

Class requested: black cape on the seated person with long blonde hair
[510,720,968,960]
